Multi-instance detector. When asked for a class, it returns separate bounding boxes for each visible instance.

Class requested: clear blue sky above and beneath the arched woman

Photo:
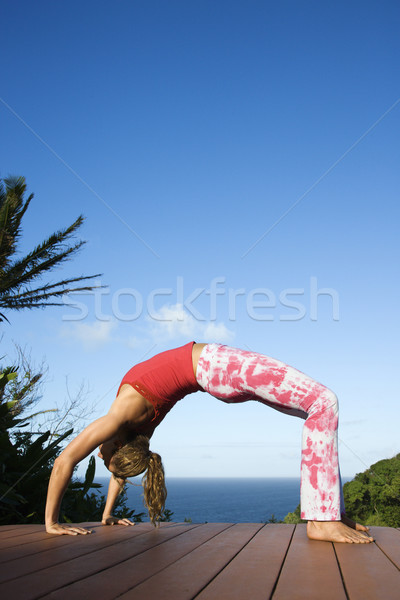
[0,0,400,477]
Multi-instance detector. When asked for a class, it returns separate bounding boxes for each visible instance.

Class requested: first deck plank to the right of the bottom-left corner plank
[46,523,231,600]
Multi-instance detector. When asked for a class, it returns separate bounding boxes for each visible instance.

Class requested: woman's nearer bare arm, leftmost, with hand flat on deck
[45,413,121,535]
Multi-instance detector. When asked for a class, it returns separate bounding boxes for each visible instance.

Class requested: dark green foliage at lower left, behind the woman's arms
[0,368,144,525]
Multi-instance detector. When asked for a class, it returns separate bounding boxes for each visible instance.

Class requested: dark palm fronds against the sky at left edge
[0,177,99,321]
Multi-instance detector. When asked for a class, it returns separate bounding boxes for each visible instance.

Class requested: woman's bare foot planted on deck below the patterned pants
[307,517,374,544]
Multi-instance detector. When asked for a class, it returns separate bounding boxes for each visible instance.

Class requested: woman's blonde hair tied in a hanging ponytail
[113,435,167,525]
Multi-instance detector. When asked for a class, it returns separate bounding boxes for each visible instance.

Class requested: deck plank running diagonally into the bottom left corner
[0,523,202,600]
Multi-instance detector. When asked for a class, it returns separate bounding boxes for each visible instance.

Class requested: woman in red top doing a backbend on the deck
[46,342,373,543]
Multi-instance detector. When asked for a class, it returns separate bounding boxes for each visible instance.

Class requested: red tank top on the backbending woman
[118,342,204,430]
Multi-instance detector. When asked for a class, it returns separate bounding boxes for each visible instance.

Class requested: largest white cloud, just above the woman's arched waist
[147,304,235,342]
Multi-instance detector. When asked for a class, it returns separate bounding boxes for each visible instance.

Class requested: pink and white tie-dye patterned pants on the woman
[196,344,344,521]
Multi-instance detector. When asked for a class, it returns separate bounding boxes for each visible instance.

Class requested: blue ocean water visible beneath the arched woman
[96,477,300,523]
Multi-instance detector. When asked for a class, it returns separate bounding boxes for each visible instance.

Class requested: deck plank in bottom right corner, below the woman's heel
[335,527,400,600]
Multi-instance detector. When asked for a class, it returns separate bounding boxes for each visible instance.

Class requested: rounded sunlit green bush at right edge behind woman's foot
[343,454,400,527]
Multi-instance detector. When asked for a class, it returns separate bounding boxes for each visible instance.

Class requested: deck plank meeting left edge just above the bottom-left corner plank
[0,525,162,583]
